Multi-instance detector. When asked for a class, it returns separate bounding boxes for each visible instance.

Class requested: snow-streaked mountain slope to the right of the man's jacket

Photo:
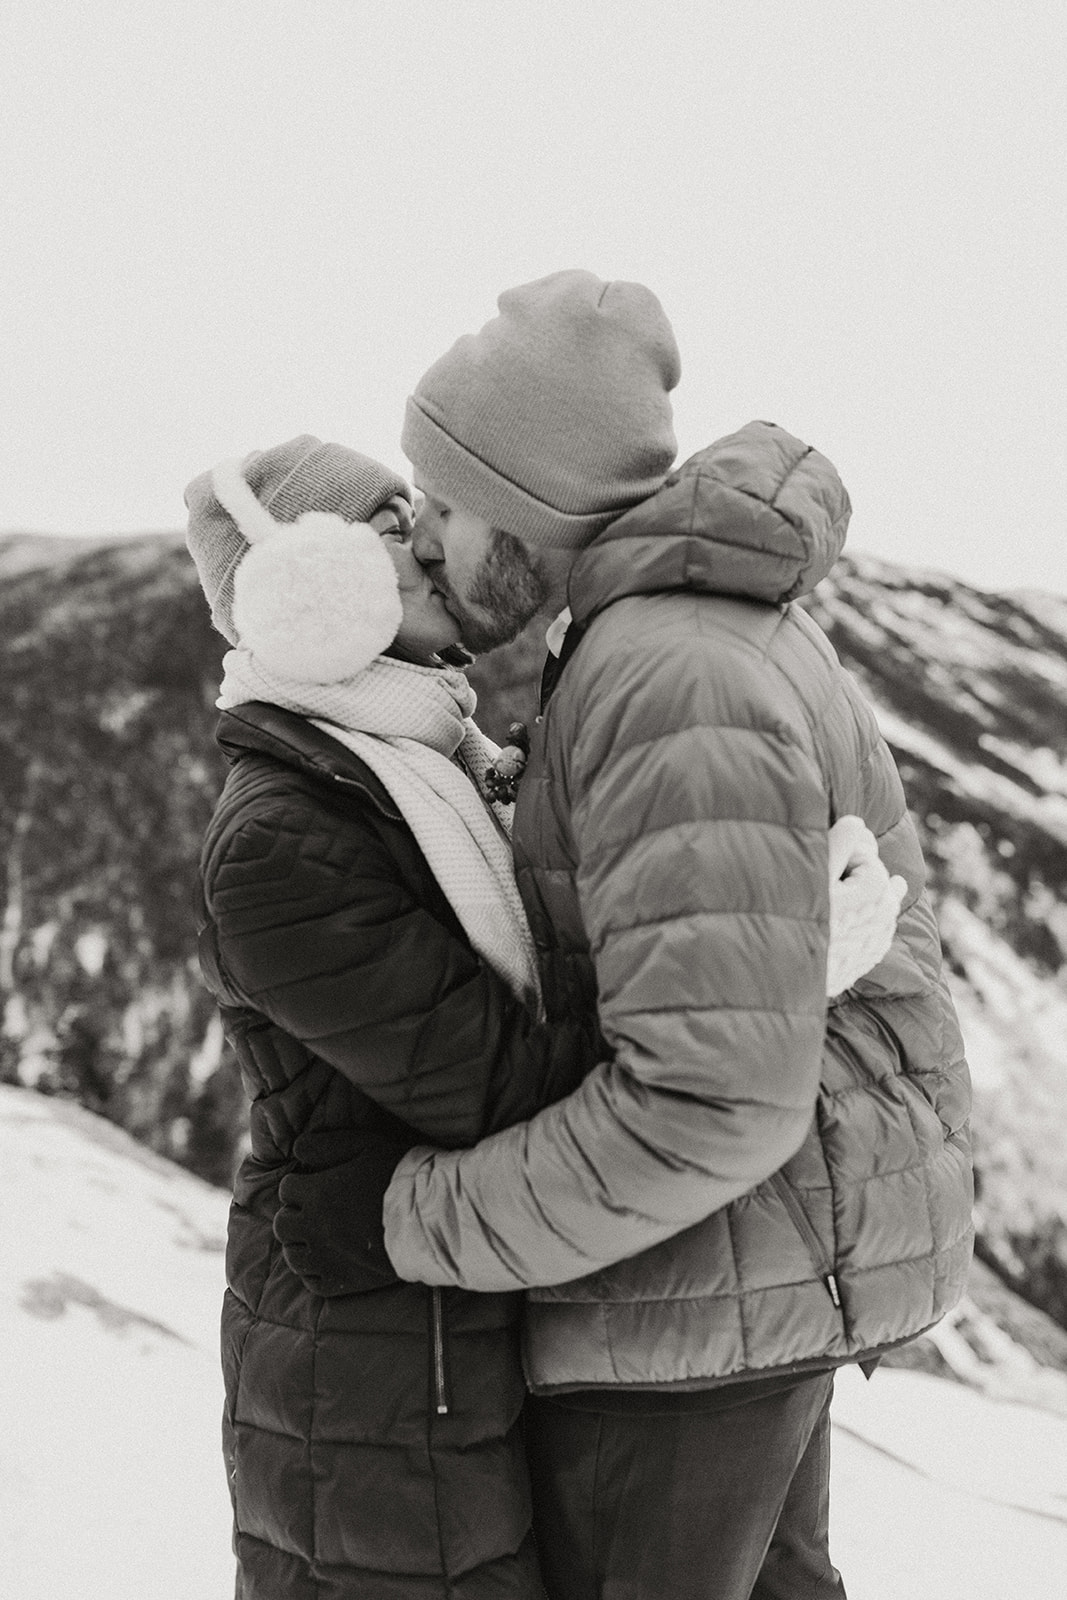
[809,557,1067,1326]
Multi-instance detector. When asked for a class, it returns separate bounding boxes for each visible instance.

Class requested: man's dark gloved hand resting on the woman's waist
[274,1130,408,1296]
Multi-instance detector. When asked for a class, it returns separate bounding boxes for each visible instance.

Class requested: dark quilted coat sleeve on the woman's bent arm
[205,797,581,1146]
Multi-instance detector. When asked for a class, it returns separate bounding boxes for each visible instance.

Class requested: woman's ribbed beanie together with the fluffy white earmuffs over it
[186,434,411,683]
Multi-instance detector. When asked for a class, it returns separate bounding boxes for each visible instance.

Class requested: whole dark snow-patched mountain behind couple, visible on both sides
[0,534,1067,1360]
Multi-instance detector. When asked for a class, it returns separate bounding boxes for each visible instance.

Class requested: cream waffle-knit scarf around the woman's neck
[216,648,541,1010]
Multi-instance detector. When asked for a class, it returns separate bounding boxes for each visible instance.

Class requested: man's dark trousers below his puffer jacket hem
[526,1373,845,1600]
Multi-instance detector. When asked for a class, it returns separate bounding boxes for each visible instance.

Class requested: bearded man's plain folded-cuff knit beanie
[402,270,680,549]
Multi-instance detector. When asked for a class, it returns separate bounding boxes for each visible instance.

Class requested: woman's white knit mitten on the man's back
[825,816,907,997]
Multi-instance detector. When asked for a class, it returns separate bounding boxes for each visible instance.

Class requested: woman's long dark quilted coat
[200,706,588,1600]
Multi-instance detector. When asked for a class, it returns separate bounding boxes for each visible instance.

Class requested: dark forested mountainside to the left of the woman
[0,534,243,1181]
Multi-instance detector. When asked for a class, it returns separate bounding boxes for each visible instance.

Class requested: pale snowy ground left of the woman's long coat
[0,1088,234,1600]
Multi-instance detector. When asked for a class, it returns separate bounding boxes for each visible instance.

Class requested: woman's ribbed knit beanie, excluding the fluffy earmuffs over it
[186,434,411,645]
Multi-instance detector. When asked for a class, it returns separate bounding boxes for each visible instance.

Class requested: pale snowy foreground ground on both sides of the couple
[0,1086,1067,1600]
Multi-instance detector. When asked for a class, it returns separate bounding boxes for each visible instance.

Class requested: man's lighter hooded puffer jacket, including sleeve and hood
[386,424,973,1390]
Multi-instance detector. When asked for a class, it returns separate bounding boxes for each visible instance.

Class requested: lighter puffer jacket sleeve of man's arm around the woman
[386,633,829,1290]
